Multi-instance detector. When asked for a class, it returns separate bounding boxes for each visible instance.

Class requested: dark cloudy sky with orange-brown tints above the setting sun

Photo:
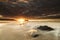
[0,0,60,18]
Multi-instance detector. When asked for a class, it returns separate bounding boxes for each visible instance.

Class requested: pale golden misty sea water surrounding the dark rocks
[0,21,60,40]
